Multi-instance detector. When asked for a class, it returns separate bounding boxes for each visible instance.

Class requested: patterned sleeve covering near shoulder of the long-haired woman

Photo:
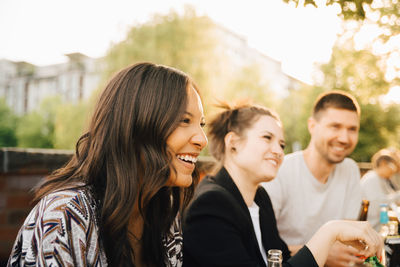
[10,189,104,266]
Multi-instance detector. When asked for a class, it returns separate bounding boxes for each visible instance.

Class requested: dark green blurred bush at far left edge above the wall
[0,99,18,147]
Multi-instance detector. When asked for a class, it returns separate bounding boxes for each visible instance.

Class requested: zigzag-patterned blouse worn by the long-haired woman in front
[7,189,183,267]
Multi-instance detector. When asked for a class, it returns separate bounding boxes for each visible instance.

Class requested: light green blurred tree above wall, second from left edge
[16,97,61,148]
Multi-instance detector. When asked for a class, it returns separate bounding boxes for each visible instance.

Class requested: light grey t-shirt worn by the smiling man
[263,151,361,245]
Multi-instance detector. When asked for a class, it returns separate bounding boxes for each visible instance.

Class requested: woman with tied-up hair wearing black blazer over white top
[183,104,382,267]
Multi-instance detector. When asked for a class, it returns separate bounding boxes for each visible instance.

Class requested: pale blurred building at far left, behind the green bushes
[0,53,102,115]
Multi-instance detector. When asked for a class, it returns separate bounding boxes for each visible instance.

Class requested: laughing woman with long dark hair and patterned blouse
[8,63,207,266]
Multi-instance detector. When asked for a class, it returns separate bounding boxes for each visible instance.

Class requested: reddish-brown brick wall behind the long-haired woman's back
[0,148,72,266]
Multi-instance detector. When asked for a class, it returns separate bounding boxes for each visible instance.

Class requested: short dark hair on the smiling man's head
[312,90,361,119]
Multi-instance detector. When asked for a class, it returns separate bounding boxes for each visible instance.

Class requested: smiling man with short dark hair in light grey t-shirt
[264,91,362,267]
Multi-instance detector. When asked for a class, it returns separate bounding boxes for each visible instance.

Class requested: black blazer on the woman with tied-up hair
[183,168,318,267]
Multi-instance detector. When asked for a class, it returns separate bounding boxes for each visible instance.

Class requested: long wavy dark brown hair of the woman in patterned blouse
[36,63,198,266]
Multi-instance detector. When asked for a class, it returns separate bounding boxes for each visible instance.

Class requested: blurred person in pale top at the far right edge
[360,149,400,231]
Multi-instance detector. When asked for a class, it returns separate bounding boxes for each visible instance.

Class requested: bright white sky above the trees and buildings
[0,0,340,85]
